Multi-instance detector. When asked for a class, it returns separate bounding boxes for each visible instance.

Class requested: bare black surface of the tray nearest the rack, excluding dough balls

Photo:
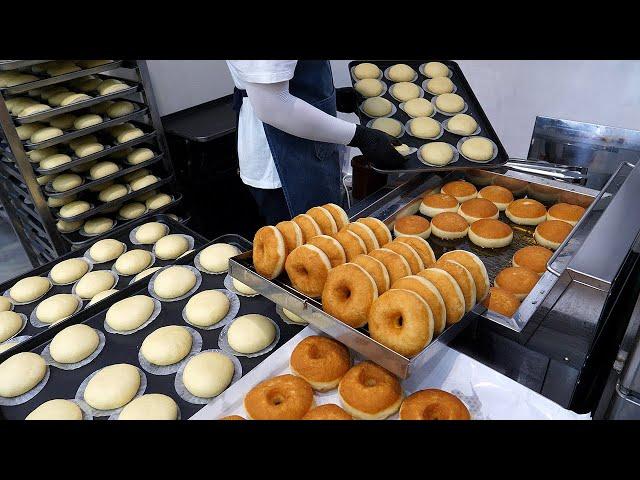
[0,214,208,352]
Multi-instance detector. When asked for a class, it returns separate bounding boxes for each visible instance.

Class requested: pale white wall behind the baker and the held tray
[149,60,640,157]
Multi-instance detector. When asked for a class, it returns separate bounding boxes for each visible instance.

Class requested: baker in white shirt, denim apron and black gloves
[227,60,405,225]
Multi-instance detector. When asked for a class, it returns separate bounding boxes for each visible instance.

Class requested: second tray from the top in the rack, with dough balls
[5,71,140,125]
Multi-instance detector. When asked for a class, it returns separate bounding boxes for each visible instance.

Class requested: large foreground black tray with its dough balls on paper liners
[0,235,304,419]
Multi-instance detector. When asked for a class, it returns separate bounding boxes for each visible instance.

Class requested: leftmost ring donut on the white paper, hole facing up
[244,375,313,420]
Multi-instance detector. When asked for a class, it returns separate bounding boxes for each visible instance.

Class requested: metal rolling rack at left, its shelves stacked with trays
[0,60,182,267]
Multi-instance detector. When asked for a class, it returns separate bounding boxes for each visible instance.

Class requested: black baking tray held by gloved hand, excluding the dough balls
[349,60,509,173]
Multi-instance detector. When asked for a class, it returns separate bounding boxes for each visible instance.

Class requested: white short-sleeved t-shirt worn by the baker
[227,60,298,189]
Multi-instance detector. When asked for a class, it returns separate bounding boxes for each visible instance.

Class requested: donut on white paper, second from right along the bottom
[338,361,402,420]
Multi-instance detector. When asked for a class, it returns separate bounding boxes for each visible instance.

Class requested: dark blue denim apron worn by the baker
[234,60,342,217]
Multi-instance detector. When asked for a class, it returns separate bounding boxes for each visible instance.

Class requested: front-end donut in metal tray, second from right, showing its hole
[322,263,378,328]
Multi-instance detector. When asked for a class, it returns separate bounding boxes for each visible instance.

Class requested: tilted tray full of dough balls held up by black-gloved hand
[349,61,508,173]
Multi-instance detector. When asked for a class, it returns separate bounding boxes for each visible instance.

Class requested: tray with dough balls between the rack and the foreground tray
[0,215,206,352]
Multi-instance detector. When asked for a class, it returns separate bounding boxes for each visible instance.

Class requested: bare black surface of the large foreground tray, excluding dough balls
[0,235,305,420]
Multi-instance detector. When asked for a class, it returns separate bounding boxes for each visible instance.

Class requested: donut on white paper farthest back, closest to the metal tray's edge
[289,335,351,392]
